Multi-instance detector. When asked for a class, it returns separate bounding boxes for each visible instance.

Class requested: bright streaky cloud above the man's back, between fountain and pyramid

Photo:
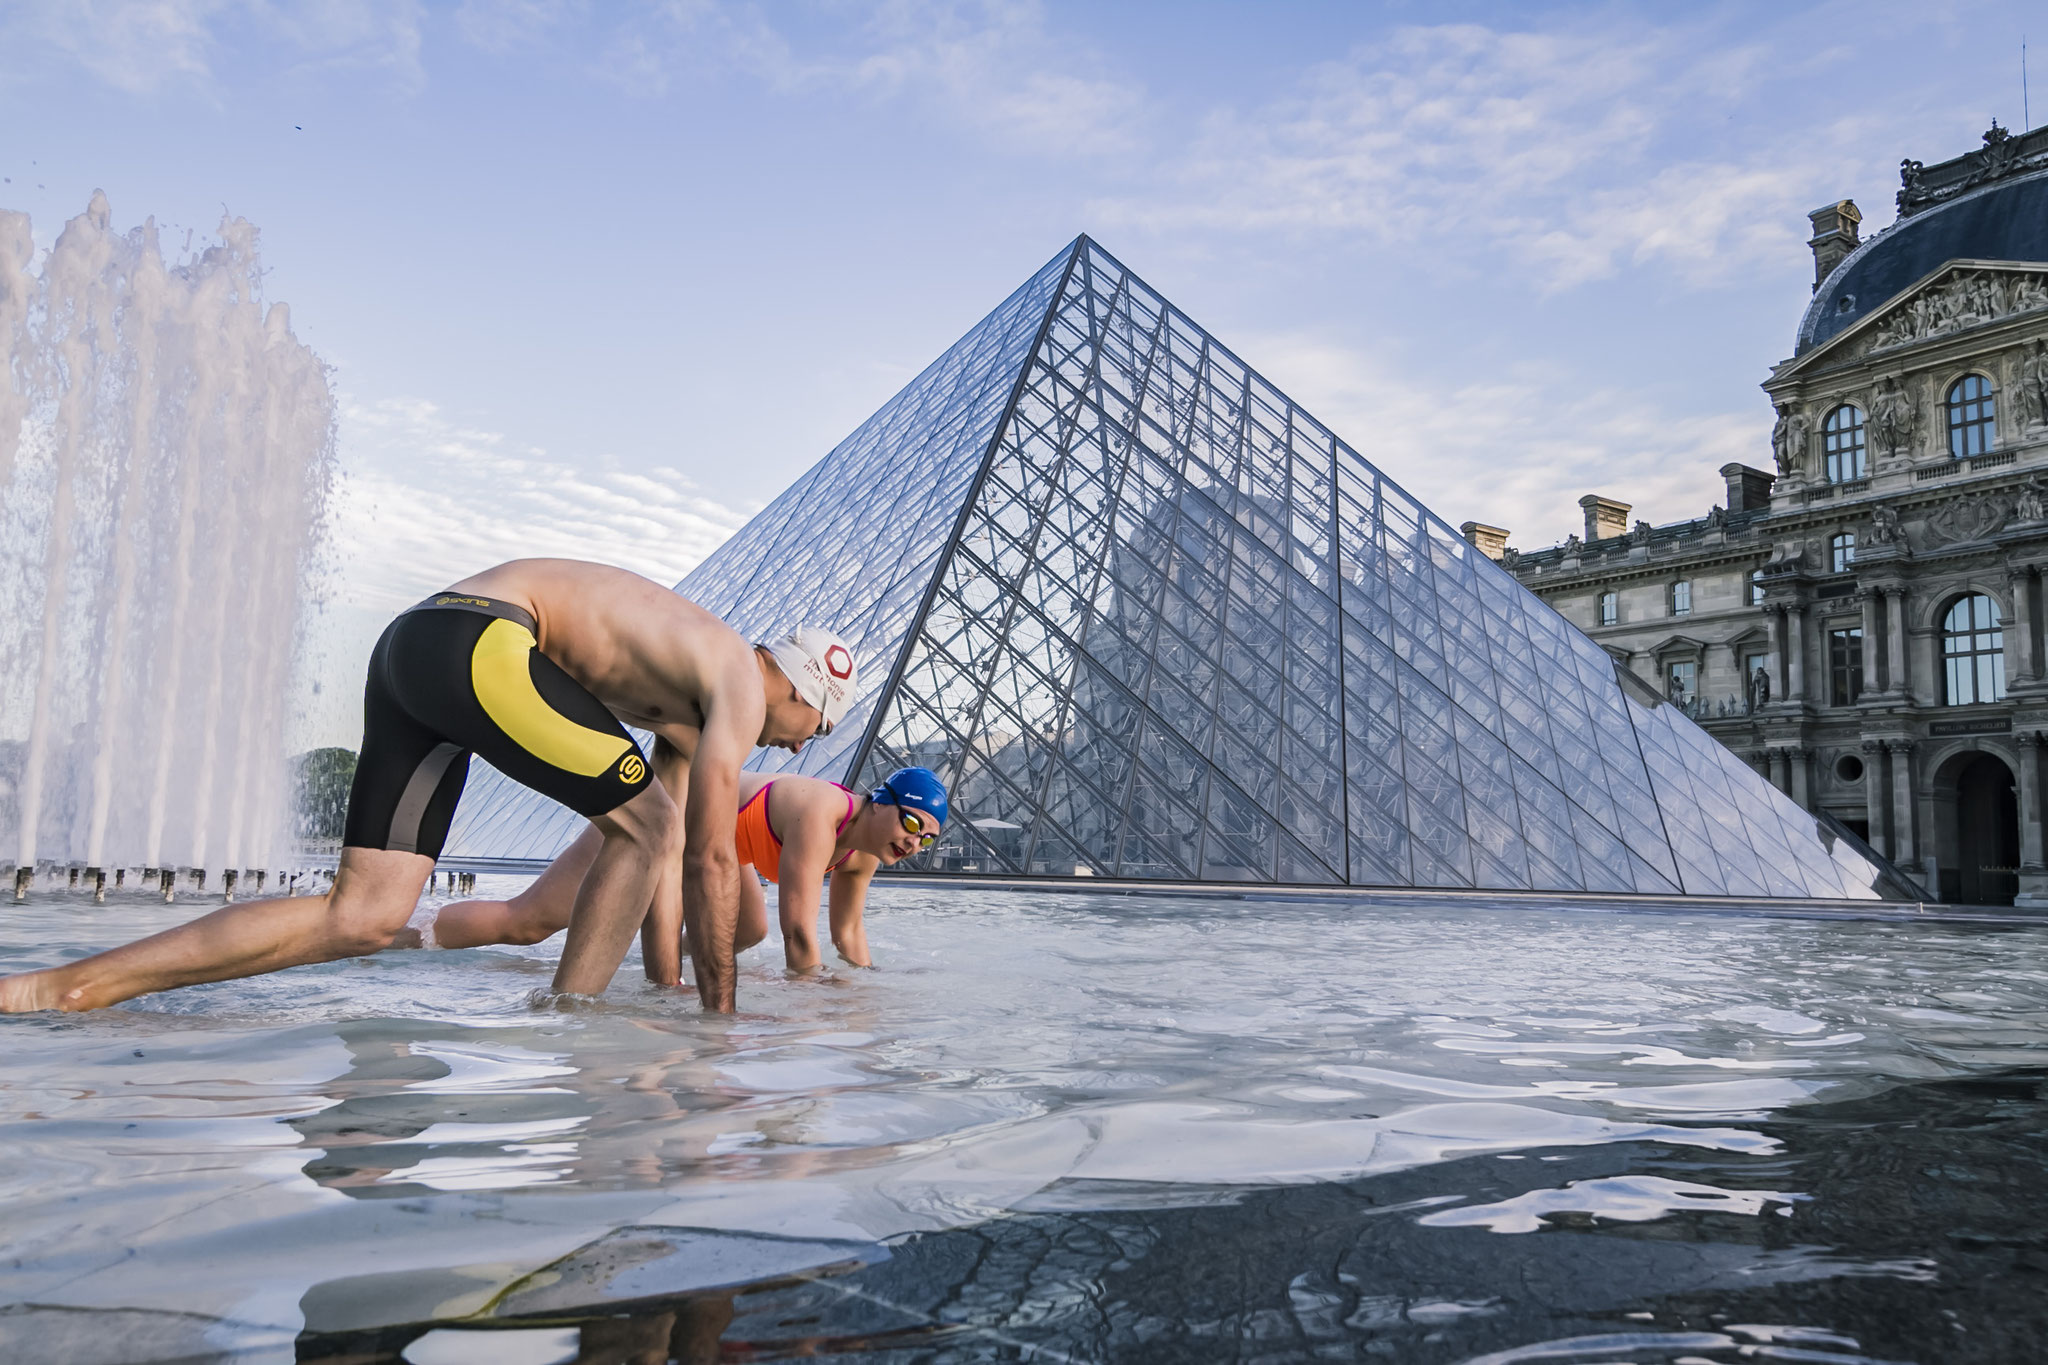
[332,399,750,612]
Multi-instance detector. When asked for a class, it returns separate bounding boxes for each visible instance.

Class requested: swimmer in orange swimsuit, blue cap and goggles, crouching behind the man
[407,767,946,972]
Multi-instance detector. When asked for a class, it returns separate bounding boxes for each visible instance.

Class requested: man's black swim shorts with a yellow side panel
[342,593,647,857]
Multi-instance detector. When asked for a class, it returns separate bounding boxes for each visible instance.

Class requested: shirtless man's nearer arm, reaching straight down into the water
[682,651,766,1013]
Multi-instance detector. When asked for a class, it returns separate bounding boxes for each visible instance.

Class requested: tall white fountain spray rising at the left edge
[0,194,334,898]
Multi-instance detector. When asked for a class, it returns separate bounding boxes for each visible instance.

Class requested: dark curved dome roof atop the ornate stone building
[1794,170,2048,354]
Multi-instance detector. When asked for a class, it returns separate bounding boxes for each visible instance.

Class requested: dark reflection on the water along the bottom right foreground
[280,1070,2048,1365]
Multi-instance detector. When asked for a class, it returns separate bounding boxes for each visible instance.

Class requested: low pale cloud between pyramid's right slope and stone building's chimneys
[1241,334,1769,548]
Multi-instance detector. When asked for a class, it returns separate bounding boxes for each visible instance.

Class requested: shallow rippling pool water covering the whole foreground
[0,878,2048,1365]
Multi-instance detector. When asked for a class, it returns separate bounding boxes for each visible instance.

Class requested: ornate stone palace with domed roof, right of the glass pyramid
[1490,125,2048,905]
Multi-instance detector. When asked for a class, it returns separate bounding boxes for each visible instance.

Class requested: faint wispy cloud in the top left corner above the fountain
[0,0,424,96]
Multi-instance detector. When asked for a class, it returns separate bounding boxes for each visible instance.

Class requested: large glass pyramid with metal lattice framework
[449,237,1911,898]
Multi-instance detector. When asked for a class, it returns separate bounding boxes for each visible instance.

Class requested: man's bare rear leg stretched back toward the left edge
[0,847,434,1013]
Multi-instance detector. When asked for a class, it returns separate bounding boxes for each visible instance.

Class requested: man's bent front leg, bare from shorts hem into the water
[555,782,682,995]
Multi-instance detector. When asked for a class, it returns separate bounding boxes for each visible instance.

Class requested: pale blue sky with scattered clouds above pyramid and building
[0,0,2048,745]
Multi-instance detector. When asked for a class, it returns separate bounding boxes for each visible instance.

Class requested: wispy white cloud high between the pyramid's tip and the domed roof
[1094,10,1875,291]
